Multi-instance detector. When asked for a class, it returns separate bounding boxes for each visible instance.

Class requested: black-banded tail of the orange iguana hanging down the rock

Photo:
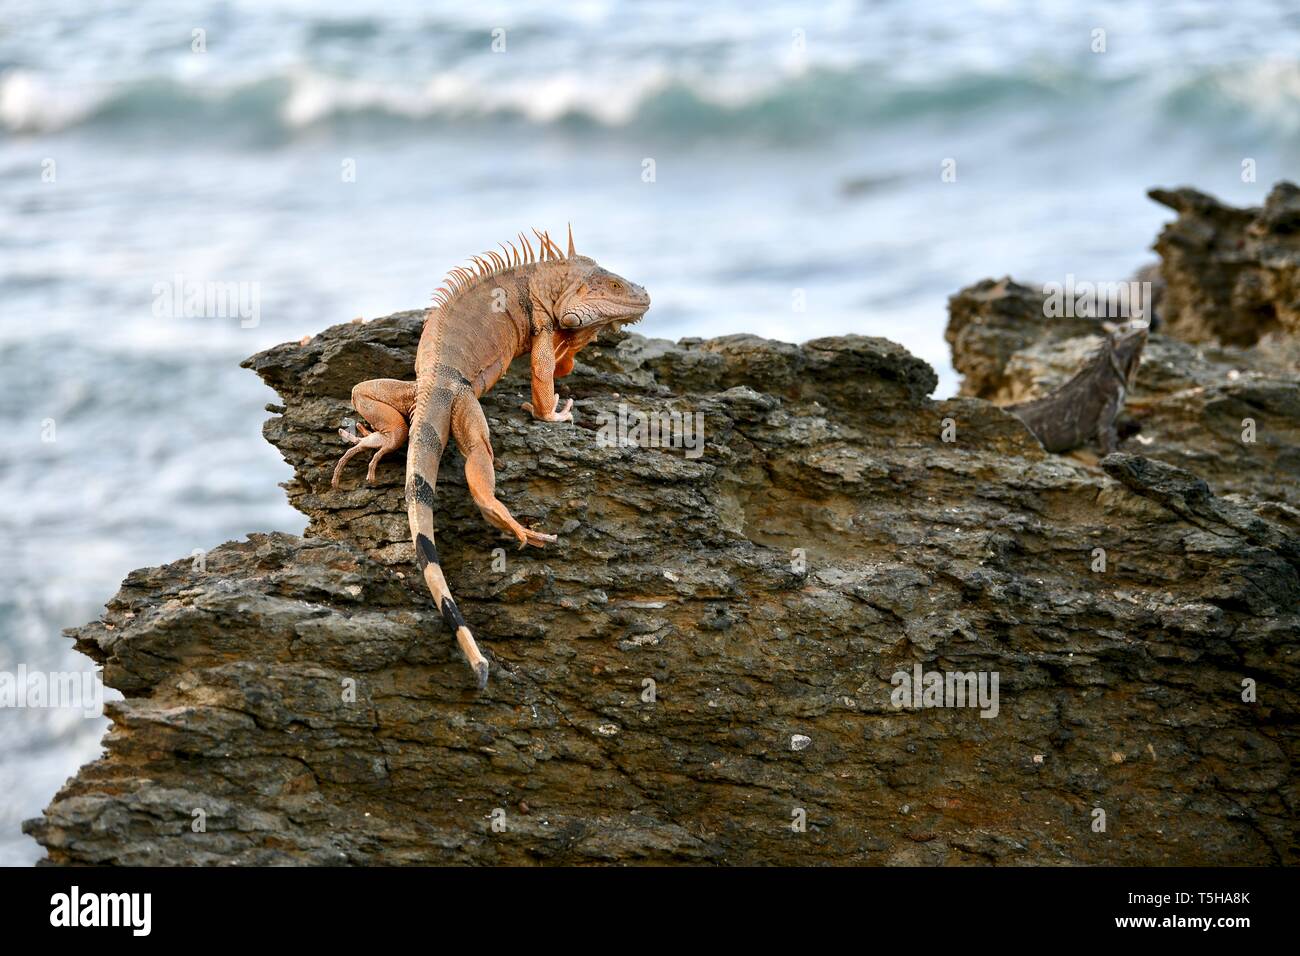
[406,382,488,689]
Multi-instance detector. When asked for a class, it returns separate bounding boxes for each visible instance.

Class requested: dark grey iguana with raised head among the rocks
[1006,326,1147,455]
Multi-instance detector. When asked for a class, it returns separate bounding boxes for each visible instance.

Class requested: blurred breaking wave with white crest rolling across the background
[0,61,1300,139]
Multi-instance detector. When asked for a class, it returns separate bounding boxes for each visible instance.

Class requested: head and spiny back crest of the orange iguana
[434,226,650,329]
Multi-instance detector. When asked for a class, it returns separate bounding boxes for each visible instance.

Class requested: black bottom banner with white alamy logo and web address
[0,868,1296,946]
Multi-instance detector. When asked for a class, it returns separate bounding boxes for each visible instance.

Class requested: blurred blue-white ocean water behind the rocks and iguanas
[0,0,1300,864]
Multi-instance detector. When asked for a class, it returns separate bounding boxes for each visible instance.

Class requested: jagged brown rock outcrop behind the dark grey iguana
[946,183,1300,509]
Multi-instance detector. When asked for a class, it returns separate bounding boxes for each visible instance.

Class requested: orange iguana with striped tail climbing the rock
[330,226,650,689]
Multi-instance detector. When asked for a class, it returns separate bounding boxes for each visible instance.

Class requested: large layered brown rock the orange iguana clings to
[29,304,1300,865]
